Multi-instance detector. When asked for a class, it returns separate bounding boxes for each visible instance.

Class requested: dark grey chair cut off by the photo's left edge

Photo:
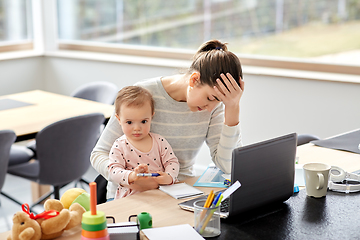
[0,130,16,206]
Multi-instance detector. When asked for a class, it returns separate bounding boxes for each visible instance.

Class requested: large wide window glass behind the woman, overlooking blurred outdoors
[58,0,360,71]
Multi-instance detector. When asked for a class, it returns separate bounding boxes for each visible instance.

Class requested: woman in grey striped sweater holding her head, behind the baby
[90,40,244,199]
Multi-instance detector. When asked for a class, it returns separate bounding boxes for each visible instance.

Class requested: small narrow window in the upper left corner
[0,0,32,52]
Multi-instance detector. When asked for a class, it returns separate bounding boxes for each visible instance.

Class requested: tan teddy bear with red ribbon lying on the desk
[7,199,86,240]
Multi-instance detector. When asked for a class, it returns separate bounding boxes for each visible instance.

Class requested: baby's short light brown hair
[115,86,155,116]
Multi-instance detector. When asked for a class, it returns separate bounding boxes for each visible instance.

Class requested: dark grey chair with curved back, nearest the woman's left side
[7,113,105,208]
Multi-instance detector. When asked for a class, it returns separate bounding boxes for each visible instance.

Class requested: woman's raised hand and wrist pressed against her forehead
[214,73,245,126]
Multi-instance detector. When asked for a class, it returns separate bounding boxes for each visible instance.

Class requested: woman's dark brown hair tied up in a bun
[188,40,243,87]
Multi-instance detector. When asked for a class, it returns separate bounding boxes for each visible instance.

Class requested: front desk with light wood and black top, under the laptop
[0,144,360,240]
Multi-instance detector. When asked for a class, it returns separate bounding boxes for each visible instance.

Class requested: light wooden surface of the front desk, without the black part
[0,144,360,240]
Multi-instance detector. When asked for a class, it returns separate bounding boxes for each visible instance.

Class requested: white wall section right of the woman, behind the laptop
[241,75,360,143]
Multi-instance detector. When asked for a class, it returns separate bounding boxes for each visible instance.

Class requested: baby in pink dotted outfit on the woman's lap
[108,86,180,199]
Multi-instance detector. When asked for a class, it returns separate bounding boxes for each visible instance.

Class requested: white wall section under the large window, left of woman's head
[44,57,180,95]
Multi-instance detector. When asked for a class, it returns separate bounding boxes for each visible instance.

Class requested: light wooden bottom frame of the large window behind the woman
[58,41,360,75]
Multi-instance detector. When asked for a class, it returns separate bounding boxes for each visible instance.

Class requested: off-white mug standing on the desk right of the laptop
[303,163,331,198]
